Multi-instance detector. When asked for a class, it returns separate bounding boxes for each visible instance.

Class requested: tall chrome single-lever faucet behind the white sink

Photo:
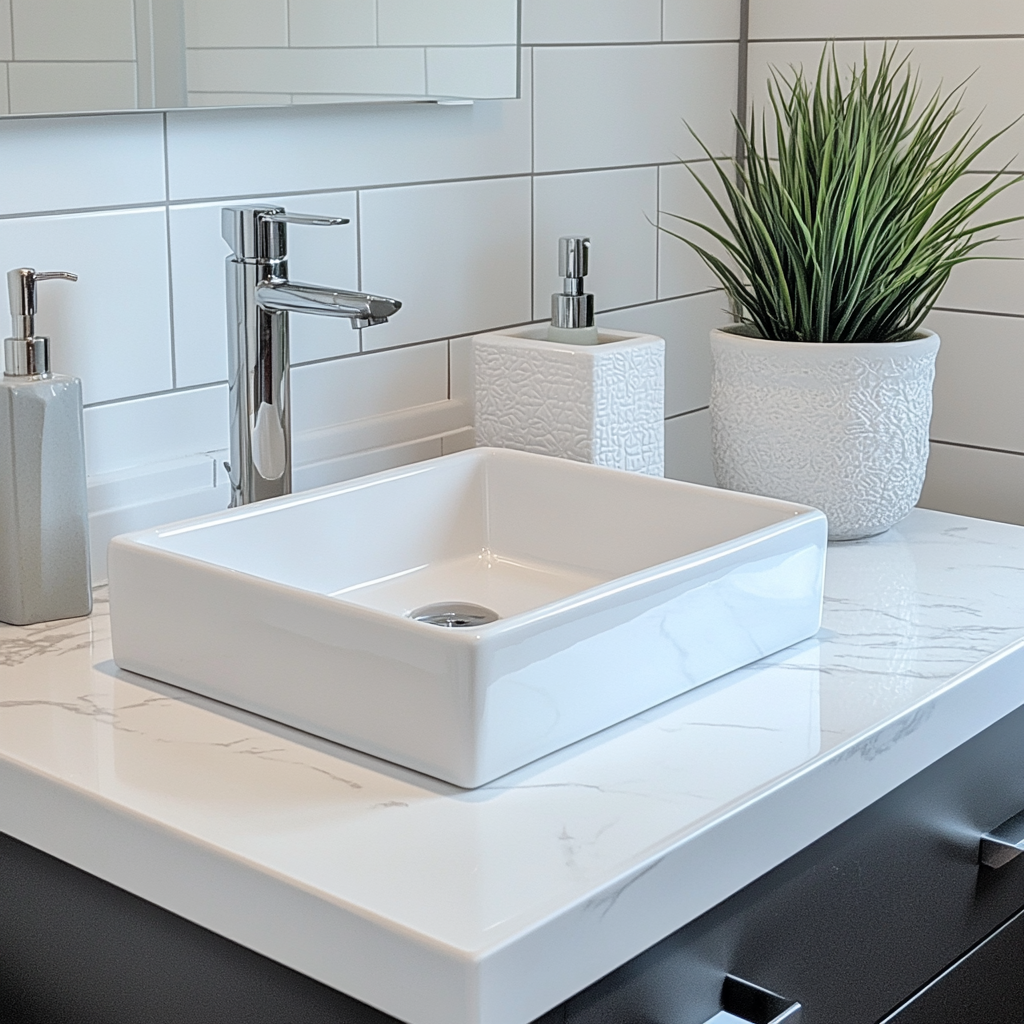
[222,206,401,508]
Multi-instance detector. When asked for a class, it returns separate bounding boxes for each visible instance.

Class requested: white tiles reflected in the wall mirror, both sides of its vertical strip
[0,0,520,114]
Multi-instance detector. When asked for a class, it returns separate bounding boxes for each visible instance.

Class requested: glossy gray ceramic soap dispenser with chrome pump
[0,267,92,626]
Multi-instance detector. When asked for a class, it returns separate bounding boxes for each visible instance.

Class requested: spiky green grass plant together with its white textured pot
[669,46,1024,540]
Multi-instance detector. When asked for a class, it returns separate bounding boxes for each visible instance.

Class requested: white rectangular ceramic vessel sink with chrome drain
[110,449,826,787]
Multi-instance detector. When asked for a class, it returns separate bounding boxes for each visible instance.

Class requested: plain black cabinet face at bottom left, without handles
[0,835,400,1024]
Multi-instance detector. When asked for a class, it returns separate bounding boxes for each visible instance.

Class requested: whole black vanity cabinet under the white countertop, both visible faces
[0,709,1024,1024]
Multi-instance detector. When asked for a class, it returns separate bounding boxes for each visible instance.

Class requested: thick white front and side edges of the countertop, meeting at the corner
[0,641,1024,1024]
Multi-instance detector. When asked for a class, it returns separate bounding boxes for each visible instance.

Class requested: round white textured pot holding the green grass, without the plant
[711,328,939,541]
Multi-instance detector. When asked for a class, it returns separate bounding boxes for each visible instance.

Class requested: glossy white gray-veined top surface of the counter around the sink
[0,510,1024,1021]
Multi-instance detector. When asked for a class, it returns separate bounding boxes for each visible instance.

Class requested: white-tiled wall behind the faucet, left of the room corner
[0,12,739,580]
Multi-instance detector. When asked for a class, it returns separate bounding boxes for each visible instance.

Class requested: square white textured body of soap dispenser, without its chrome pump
[473,327,665,476]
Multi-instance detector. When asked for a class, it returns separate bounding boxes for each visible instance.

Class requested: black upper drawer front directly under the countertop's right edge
[564,709,1024,1024]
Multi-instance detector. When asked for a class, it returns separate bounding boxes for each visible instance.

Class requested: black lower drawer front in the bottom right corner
[882,911,1024,1024]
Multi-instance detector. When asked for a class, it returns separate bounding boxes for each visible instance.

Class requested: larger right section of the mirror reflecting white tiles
[180,0,518,105]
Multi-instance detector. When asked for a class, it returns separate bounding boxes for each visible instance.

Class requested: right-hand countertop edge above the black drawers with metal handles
[481,641,1024,1024]
